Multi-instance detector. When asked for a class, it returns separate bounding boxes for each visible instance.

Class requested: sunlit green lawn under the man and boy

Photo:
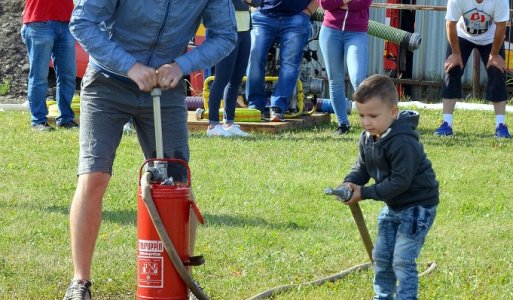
[0,110,513,299]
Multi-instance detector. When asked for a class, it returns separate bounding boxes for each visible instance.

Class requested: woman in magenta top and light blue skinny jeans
[318,0,372,134]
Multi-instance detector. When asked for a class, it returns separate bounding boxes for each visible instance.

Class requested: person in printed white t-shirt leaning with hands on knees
[435,0,511,138]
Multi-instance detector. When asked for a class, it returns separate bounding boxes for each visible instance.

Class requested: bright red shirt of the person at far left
[23,0,74,24]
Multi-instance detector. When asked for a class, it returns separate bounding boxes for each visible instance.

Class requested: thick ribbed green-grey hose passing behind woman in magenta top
[310,8,421,51]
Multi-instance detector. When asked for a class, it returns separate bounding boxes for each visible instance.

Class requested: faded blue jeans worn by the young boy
[372,205,437,300]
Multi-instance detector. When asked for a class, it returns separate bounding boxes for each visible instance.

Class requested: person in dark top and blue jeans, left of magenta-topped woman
[246,0,318,122]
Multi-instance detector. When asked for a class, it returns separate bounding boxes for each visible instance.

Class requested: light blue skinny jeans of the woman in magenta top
[319,26,368,125]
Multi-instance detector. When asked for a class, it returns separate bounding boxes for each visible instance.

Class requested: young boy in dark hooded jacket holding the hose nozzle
[342,75,438,299]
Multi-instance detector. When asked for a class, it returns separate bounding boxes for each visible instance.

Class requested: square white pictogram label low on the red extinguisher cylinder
[137,256,164,288]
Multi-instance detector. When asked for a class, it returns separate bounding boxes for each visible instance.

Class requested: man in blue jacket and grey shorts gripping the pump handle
[64,0,237,299]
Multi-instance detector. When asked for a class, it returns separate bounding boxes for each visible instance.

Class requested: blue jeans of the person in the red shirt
[21,21,77,125]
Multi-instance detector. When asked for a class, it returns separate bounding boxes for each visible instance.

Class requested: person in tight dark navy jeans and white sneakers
[207,0,262,136]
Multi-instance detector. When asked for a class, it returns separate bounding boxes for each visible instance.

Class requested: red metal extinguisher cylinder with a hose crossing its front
[137,183,191,300]
